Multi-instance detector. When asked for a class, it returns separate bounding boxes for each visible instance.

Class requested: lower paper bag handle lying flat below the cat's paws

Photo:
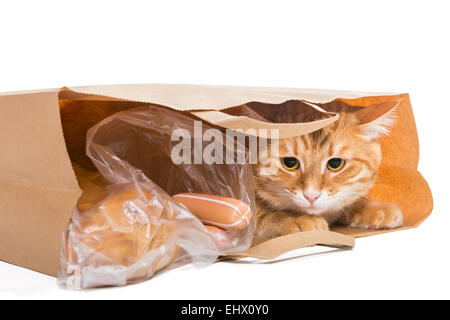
[231,231,355,260]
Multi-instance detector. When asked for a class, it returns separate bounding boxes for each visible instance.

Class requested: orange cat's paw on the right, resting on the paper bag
[349,203,403,229]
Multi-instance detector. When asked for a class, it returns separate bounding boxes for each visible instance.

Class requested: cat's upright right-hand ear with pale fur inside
[356,101,400,141]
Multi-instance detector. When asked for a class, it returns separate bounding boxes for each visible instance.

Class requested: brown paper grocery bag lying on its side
[0,85,432,275]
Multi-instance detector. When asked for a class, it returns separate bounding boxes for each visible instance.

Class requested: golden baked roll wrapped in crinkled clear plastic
[59,183,184,289]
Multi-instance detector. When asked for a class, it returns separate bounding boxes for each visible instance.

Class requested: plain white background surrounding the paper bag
[0,0,450,299]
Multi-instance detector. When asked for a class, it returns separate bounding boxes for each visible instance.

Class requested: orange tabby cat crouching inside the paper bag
[254,105,403,237]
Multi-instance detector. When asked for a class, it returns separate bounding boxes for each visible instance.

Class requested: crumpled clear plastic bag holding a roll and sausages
[58,106,255,288]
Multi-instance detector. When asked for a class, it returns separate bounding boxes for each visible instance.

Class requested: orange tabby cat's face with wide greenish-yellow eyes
[254,107,393,214]
